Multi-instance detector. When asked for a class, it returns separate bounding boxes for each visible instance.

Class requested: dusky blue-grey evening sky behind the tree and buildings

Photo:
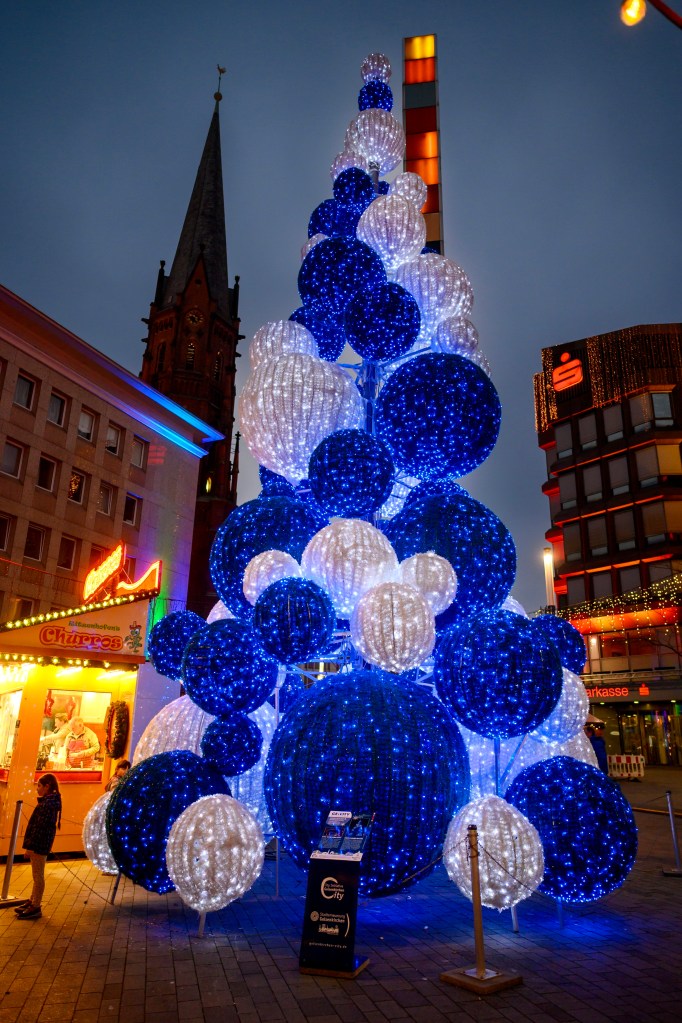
[0,0,682,610]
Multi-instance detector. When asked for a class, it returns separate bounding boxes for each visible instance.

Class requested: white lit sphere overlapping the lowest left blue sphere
[166,794,265,913]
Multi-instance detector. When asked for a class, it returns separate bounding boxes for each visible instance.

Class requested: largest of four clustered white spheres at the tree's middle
[301,519,398,618]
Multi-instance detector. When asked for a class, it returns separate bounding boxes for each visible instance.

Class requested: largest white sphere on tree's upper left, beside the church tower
[239,354,364,484]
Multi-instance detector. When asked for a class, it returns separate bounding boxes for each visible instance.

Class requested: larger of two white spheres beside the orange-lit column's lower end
[356,195,426,273]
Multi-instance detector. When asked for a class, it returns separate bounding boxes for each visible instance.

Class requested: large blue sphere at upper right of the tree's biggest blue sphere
[434,611,563,739]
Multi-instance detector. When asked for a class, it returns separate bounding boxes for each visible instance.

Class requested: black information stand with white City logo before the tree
[299,810,373,979]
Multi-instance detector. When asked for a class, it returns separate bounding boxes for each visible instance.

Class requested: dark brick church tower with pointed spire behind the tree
[140,92,240,616]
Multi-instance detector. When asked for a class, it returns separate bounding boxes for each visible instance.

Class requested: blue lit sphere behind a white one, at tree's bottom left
[106,750,230,895]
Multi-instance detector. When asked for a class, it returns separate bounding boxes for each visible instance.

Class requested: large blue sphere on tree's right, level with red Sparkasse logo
[376,351,500,480]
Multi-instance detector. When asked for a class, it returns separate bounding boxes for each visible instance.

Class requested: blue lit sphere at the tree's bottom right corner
[505,757,637,902]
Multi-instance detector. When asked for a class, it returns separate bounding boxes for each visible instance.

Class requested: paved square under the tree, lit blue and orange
[0,768,682,1023]
